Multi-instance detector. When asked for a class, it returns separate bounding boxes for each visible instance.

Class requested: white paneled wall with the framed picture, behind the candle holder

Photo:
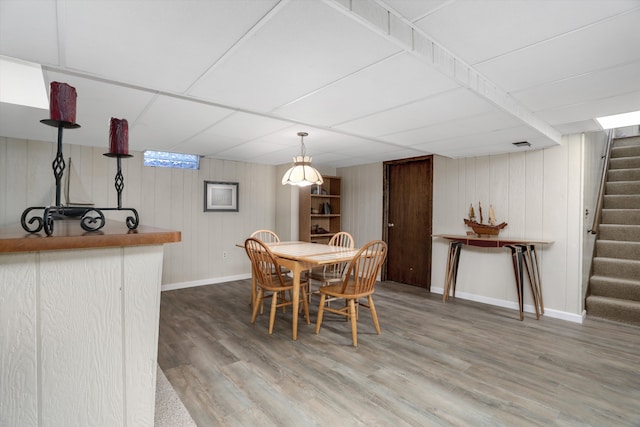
[0,137,279,286]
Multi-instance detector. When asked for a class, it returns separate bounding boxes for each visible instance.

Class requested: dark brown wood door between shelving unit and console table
[383,156,433,289]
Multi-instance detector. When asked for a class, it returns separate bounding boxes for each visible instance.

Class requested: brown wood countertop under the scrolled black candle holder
[0,220,182,253]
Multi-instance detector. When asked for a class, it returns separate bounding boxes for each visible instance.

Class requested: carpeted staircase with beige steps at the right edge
[586,136,640,325]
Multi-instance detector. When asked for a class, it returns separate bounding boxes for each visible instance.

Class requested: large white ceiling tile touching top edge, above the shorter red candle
[62,0,277,93]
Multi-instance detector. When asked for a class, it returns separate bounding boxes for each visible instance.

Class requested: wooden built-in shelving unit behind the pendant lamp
[298,176,341,243]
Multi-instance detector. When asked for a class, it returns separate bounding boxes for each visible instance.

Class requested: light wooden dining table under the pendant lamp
[242,241,358,340]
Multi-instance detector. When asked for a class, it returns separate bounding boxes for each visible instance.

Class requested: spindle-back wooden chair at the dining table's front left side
[244,237,310,334]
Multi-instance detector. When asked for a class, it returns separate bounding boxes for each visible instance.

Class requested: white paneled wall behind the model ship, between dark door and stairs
[432,135,596,321]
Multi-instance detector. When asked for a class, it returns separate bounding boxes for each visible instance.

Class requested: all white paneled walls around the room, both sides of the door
[0,135,597,321]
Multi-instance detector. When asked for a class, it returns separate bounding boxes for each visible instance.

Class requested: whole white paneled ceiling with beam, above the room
[0,0,640,167]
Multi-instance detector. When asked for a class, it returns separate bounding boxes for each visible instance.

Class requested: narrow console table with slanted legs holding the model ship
[433,234,552,320]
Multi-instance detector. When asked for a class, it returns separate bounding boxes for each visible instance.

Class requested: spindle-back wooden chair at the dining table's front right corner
[316,240,387,347]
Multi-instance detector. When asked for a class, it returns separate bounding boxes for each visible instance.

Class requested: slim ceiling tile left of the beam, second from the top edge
[274,53,457,126]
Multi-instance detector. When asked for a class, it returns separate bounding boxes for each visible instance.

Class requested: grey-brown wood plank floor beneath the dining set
[158,280,640,426]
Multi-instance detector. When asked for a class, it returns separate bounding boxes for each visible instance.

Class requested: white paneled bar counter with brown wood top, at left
[0,220,181,427]
